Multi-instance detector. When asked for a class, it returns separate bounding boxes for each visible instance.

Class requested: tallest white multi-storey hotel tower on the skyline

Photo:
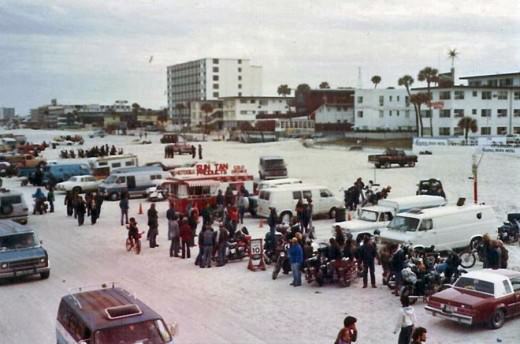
[166,58,262,124]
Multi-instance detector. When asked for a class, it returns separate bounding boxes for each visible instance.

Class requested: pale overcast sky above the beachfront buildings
[0,0,520,115]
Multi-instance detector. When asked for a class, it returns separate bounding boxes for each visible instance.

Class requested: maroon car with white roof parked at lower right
[425,269,520,329]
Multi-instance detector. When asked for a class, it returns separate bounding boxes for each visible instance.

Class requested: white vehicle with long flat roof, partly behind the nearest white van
[332,195,447,239]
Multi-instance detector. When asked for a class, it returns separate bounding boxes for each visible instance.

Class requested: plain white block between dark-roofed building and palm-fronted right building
[354,88,415,131]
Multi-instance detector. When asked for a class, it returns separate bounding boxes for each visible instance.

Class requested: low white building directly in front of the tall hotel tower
[220,96,294,128]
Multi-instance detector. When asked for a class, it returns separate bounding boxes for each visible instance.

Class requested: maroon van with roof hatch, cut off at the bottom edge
[56,285,175,344]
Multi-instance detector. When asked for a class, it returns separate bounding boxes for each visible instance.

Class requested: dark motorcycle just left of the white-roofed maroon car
[399,263,442,304]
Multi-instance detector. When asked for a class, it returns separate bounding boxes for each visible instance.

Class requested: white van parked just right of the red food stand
[257,184,343,221]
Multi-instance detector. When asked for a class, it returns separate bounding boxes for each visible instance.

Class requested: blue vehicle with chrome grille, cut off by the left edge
[0,220,51,279]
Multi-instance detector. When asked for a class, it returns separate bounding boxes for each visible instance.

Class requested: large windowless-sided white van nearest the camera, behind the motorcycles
[381,205,498,251]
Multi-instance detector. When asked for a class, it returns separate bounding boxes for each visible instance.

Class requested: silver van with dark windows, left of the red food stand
[98,166,171,201]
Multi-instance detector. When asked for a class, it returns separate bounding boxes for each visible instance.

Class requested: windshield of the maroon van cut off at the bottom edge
[94,320,171,344]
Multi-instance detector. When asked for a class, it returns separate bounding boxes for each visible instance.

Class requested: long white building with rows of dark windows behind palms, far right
[413,73,520,136]
